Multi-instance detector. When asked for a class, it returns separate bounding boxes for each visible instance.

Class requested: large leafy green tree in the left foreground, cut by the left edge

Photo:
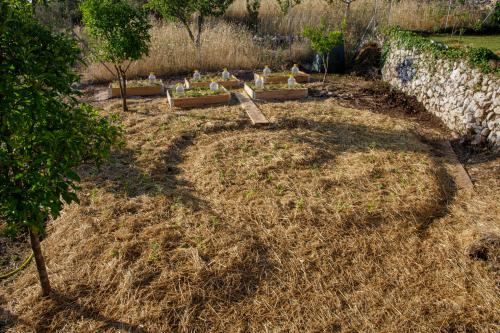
[0,0,120,296]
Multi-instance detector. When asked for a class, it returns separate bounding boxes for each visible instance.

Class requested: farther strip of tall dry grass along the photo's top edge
[226,0,489,35]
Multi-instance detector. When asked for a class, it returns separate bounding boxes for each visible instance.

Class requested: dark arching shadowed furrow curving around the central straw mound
[90,117,457,233]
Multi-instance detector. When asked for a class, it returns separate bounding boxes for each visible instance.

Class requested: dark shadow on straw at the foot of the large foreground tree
[31,286,148,333]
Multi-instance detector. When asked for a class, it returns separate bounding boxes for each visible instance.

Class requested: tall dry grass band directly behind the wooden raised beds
[83,20,309,82]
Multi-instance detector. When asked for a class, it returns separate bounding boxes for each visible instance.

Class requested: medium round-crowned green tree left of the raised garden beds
[80,0,151,111]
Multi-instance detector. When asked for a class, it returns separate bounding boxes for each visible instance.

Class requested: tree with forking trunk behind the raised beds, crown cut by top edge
[146,0,234,65]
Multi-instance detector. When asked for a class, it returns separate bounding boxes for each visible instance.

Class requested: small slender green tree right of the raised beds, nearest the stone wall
[303,23,342,84]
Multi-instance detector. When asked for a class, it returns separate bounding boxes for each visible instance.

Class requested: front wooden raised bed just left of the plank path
[167,86,231,108]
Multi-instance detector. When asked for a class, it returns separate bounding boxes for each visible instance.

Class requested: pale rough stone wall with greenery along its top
[382,47,500,149]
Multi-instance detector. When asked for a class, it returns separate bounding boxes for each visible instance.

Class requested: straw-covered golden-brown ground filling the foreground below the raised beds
[0,77,500,332]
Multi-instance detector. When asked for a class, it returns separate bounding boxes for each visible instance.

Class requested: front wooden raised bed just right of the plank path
[244,83,308,101]
